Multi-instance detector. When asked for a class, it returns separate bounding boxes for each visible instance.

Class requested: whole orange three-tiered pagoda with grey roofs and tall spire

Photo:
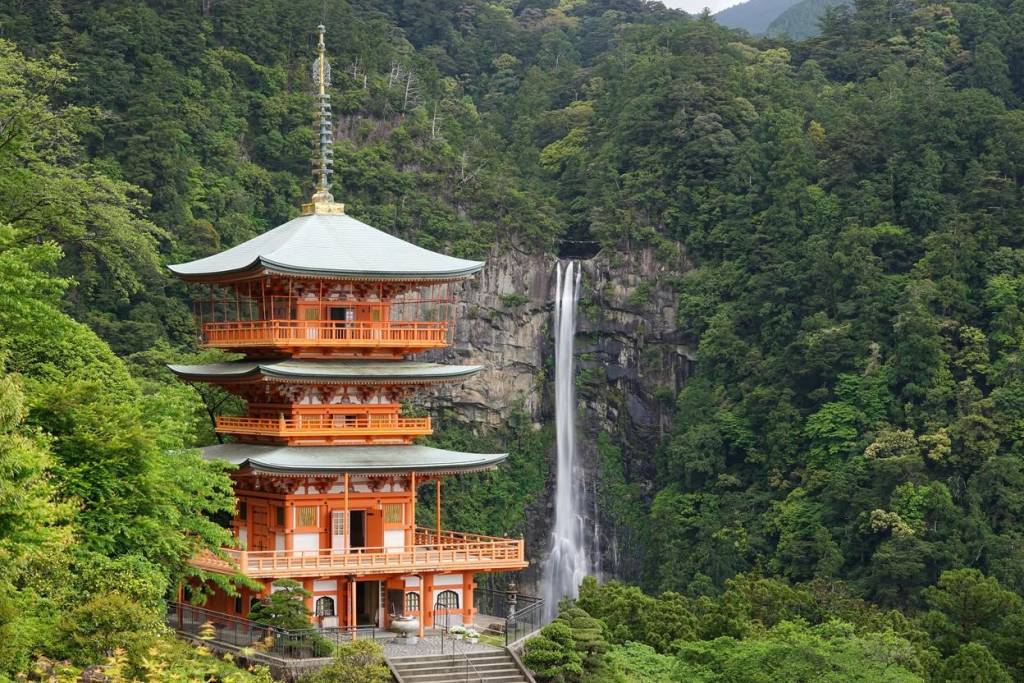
[171,27,526,629]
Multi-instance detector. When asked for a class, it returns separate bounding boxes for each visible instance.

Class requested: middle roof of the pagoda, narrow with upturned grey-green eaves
[167,358,481,384]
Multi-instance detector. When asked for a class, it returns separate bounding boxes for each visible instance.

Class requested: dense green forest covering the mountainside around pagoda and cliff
[0,0,1024,681]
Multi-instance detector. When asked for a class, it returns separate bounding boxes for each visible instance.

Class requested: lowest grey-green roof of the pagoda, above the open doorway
[202,443,508,476]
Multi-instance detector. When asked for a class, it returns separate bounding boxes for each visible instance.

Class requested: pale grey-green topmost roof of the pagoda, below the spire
[168,213,483,283]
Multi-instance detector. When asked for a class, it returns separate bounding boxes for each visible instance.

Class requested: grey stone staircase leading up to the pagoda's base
[387,648,534,683]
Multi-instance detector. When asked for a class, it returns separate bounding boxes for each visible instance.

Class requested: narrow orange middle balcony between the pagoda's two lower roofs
[217,415,433,443]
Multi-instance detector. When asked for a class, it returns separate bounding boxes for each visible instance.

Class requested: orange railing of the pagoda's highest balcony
[203,321,451,349]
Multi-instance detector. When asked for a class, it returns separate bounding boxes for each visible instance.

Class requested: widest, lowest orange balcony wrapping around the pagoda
[191,528,528,579]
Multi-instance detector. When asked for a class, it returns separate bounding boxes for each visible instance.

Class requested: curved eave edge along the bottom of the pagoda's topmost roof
[167,257,485,284]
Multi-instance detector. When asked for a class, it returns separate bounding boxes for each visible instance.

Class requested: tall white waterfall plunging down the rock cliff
[544,261,590,621]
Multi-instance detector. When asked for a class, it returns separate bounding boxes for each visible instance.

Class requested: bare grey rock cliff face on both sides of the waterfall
[419,251,694,587]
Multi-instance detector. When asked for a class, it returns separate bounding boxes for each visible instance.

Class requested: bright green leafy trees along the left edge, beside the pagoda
[0,41,241,680]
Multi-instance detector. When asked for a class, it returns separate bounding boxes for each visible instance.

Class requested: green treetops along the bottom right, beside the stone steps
[524,569,1024,683]
